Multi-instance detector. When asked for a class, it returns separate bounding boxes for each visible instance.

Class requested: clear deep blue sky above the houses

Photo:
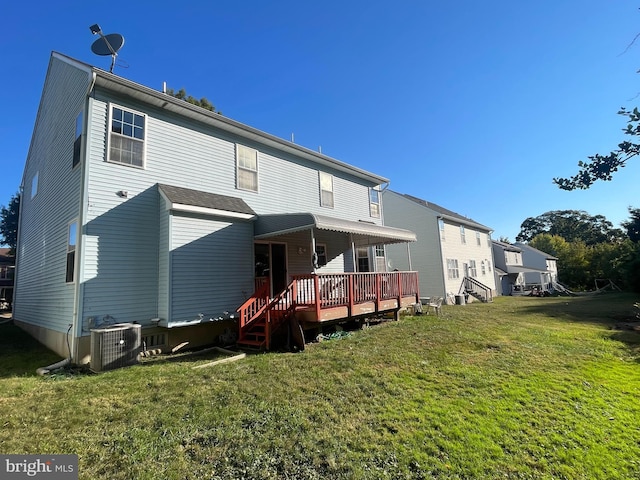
[0,0,640,241]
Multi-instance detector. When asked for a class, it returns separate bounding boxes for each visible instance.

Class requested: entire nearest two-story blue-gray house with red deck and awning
[14,52,417,363]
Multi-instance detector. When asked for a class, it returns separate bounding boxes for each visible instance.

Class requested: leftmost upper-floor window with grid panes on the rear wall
[109,106,146,167]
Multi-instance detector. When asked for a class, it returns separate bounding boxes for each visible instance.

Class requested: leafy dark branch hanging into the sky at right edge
[553,108,640,190]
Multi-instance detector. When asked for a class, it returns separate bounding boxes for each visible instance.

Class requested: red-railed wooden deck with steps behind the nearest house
[238,272,419,349]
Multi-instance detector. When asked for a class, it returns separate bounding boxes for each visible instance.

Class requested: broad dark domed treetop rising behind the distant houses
[516,210,625,246]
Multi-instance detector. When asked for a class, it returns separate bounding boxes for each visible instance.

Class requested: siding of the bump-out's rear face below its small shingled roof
[170,214,254,322]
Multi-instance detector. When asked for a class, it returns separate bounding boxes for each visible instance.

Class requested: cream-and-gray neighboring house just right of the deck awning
[382,189,496,301]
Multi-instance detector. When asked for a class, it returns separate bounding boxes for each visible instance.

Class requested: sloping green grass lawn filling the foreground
[0,294,640,480]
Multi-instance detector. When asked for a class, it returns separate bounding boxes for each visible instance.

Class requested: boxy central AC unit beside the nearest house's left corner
[90,323,142,372]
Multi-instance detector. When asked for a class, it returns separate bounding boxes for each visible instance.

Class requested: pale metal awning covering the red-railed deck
[254,213,416,245]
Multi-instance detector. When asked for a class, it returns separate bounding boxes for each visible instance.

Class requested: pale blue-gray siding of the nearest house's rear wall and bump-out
[83,91,381,323]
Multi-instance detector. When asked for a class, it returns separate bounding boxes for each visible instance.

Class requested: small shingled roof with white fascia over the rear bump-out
[158,183,256,219]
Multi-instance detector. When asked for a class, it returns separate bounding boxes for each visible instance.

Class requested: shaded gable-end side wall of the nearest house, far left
[13,57,89,332]
